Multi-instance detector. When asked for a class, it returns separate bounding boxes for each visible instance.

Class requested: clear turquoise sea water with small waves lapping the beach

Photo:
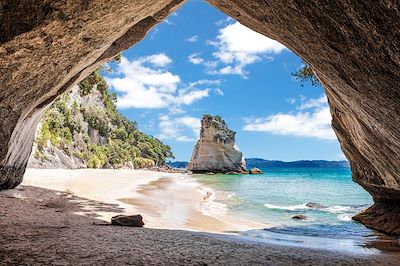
[196,168,390,251]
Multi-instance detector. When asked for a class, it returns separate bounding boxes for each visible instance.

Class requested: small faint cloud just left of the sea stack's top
[158,115,200,142]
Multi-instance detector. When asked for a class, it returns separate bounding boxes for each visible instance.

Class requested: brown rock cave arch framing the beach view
[0,0,400,234]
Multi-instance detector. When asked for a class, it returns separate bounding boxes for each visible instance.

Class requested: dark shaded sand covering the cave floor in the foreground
[0,186,400,265]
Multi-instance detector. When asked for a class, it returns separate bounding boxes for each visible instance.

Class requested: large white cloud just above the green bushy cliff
[107,54,210,109]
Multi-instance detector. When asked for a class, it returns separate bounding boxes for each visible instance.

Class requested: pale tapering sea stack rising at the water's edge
[187,115,247,173]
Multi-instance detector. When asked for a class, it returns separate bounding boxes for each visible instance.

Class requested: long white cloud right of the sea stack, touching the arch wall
[243,95,336,140]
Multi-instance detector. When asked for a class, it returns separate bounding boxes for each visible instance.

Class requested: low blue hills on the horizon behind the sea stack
[167,158,350,168]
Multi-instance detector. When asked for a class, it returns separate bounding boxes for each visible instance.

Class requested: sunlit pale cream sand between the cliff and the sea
[22,168,267,233]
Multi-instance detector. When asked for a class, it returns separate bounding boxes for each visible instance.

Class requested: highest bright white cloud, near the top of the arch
[188,22,286,78]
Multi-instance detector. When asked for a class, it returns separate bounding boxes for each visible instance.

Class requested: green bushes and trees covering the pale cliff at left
[34,68,174,168]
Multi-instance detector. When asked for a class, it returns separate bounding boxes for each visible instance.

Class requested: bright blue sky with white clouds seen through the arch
[106,0,344,161]
